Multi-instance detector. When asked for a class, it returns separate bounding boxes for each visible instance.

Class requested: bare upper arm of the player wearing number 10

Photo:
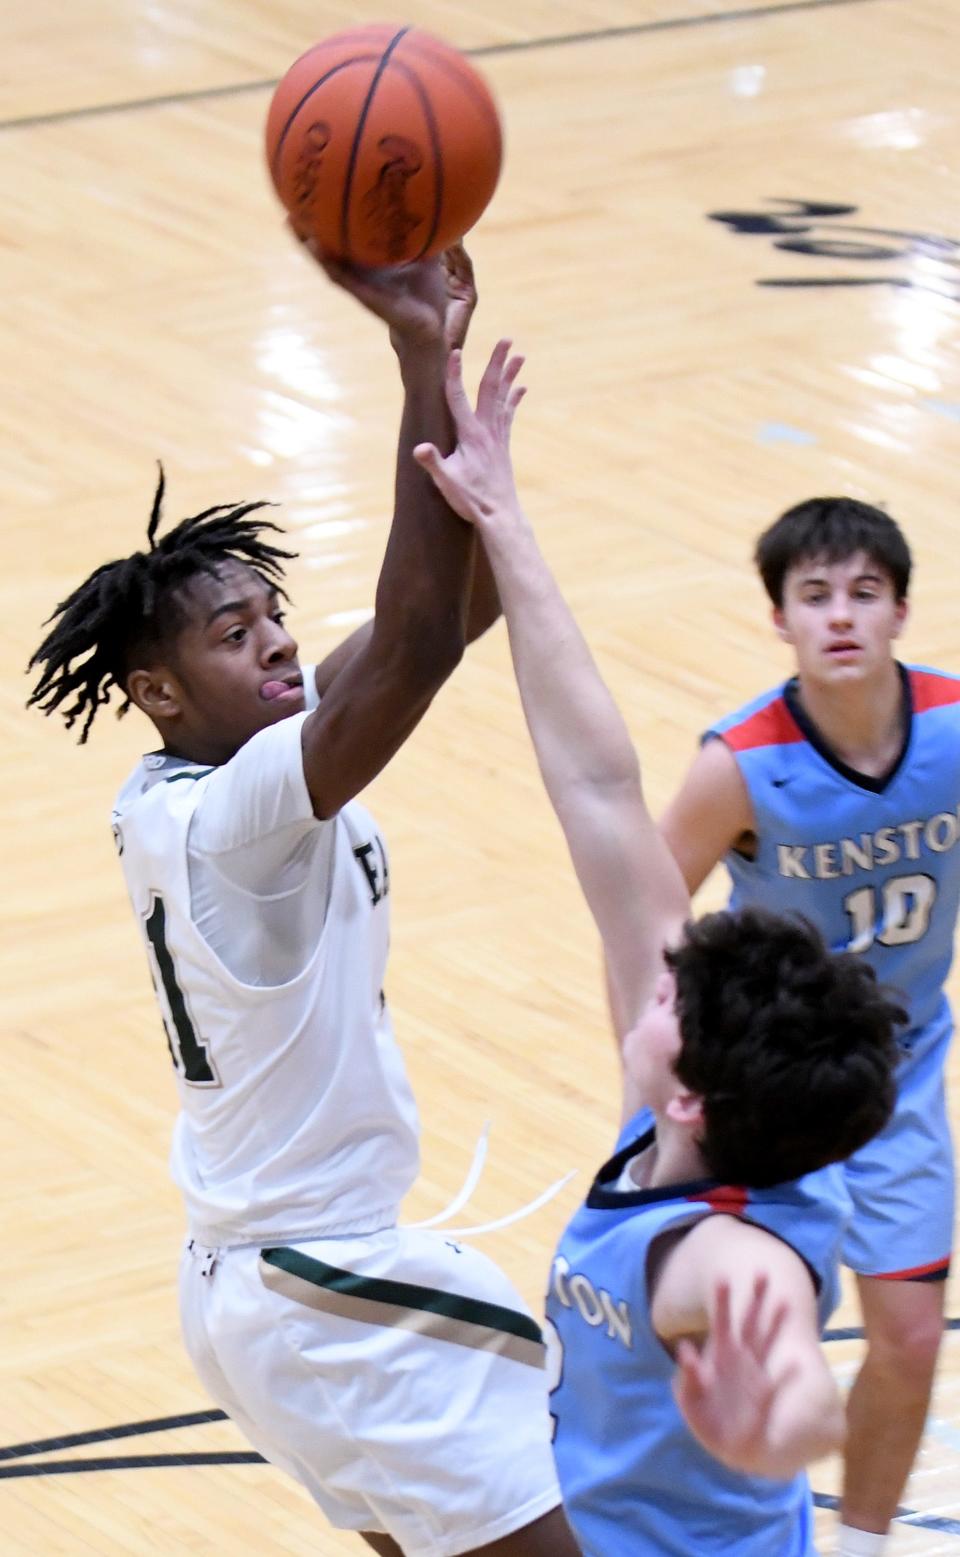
[660,738,755,897]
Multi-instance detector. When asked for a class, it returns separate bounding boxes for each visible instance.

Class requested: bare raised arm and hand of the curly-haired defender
[417,341,689,1015]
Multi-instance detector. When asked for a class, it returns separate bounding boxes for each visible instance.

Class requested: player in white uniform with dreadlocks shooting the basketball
[31,242,577,1557]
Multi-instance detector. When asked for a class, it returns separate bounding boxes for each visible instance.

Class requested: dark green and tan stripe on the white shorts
[260,1249,546,1369]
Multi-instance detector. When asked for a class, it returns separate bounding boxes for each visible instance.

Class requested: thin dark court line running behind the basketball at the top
[0,0,876,131]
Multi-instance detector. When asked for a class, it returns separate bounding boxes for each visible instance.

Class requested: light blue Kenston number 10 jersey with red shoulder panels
[705,666,960,1051]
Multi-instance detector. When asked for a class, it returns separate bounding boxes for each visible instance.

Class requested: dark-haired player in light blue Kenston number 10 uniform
[663,498,960,1552]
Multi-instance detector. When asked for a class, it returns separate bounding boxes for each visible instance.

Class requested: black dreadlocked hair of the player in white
[26,466,296,746]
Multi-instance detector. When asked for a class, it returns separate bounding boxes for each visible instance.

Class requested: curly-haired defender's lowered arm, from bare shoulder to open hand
[652,1216,845,1479]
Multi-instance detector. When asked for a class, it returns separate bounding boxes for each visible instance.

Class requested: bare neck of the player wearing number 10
[790,660,904,779]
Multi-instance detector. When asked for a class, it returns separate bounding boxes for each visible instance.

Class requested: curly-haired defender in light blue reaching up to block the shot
[417,360,906,1557]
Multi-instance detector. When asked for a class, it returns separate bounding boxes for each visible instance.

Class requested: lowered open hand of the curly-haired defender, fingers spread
[674,1275,795,1473]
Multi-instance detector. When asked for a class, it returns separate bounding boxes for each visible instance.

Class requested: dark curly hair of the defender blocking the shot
[666,908,907,1188]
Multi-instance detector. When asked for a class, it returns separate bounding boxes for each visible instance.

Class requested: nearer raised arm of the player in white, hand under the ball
[287,243,475,816]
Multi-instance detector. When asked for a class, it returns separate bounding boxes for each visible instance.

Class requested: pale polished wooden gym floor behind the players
[0,0,960,1557]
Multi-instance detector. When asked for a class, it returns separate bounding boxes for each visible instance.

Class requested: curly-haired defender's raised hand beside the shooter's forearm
[414,341,526,528]
